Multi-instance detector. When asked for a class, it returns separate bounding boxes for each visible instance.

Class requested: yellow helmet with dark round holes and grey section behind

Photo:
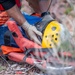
[36,12,68,48]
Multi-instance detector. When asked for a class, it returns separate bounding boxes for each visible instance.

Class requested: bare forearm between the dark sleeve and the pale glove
[6,5,26,25]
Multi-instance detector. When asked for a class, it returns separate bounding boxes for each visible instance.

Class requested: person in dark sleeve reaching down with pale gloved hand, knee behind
[0,0,49,45]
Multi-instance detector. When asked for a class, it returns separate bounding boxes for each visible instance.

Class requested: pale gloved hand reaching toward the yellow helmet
[21,21,42,45]
